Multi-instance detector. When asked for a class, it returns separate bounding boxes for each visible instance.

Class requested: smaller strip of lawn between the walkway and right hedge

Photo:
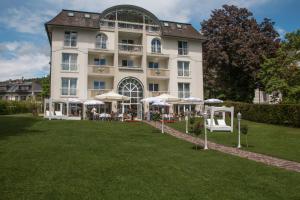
[168,120,300,162]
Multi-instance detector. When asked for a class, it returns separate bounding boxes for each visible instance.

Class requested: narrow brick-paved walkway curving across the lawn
[144,121,300,172]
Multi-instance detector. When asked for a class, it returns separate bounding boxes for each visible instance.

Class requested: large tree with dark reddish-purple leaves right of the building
[201,5,279,102]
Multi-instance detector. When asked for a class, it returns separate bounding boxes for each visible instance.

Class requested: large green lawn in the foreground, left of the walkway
[0,116,300,200]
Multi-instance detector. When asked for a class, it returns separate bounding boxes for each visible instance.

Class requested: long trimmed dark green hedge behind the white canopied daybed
[224,102,300,127]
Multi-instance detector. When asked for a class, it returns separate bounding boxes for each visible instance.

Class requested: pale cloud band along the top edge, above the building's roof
[47,0,271,22]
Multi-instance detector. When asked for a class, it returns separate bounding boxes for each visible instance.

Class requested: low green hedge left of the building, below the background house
[0,100,40,115]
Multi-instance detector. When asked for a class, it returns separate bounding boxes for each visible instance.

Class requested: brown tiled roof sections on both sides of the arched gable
[45,10,205,40]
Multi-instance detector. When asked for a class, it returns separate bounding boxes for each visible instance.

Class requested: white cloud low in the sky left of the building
[0,41,49,81]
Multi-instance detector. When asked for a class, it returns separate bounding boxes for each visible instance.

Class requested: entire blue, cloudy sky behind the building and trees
[0,0,300,81]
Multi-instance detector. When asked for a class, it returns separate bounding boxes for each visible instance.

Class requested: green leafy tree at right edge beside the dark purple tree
[258,30,300,103]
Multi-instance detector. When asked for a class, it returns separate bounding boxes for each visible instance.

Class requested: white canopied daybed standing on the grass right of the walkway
[205,106,234,132]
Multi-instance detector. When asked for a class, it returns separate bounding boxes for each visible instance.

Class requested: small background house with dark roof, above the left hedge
[0,80,42,101]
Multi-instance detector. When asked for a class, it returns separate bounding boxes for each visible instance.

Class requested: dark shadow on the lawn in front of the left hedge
[0,116,42,140]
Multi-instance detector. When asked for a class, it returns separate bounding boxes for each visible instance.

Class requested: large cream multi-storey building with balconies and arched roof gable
[45,5,203,119]
